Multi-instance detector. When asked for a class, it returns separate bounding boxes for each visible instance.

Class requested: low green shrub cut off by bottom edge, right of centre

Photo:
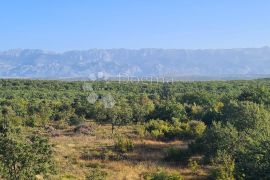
[143,170,183,180]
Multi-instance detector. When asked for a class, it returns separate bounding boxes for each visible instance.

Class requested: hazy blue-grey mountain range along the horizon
[0,47,270,79]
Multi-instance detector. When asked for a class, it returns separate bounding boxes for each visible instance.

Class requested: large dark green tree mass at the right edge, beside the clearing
[198,102,270,179]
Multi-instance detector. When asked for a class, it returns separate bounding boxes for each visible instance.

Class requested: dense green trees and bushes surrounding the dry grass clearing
[0,79,270,179]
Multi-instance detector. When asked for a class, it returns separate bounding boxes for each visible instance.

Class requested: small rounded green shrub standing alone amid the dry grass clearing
[114,136,134,153]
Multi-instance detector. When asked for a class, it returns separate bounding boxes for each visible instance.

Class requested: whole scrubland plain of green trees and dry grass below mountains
[0,79,270,180]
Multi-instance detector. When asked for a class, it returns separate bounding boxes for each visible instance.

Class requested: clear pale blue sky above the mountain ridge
[0,0,270,51]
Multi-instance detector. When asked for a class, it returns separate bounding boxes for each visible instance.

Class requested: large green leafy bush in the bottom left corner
[0,126,53,180]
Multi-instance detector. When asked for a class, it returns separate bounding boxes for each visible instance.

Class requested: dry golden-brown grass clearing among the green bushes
[51,121,207,180]
